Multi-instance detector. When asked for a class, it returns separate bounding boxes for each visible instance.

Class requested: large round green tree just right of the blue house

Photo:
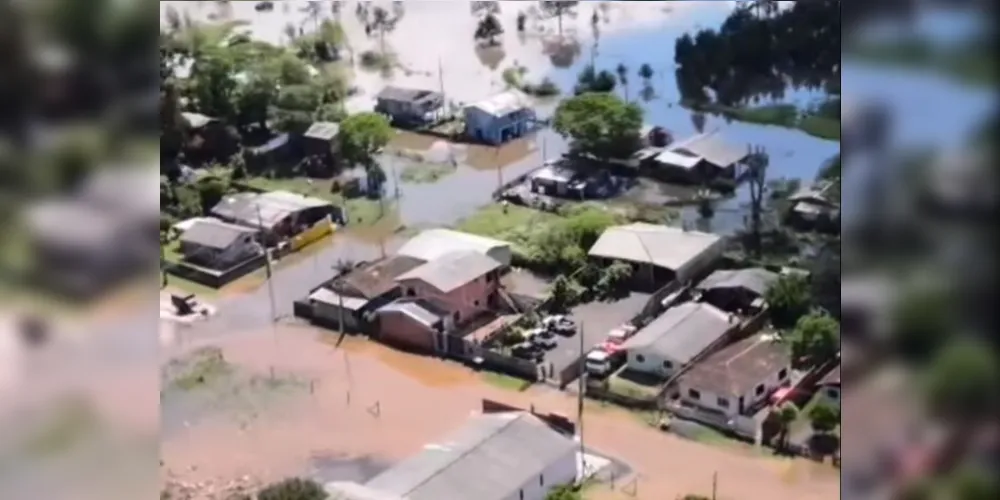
[553,93,643,160]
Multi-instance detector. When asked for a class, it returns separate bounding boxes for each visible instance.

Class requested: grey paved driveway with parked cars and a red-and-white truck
[545,293,649,386]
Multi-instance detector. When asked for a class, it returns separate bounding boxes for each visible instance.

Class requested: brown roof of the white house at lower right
[681,335,791,397]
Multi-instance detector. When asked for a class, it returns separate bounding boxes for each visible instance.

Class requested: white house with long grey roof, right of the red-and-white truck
[622,302,738,379]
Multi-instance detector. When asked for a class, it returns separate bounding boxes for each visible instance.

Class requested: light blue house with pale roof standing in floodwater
[465,90,538,145]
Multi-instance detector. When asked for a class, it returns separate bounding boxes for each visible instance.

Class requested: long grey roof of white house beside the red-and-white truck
[623,302,733,364]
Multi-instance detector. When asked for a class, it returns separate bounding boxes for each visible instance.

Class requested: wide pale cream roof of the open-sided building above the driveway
[588,222,722,271]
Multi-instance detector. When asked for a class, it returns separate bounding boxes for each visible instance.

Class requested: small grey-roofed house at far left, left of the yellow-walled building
[180,218,264,270]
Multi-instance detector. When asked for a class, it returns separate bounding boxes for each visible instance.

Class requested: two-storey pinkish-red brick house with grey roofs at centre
[378,250,502,352]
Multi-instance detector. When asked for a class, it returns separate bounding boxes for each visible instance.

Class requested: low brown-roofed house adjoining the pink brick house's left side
[309,255,425,332]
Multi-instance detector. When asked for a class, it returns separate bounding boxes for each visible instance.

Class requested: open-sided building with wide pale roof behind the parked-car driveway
[588,222,726,289]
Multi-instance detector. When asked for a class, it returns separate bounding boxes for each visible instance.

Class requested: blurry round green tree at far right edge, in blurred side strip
[924,337,1000,428]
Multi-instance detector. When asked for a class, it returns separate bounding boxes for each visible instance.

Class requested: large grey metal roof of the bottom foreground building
[367,413,577,500]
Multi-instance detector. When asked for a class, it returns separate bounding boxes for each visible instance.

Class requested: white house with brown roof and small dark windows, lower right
[677,335,792,418]
